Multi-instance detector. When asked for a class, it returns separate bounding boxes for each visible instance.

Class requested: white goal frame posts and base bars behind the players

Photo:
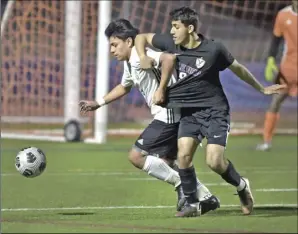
[1,0,112,144]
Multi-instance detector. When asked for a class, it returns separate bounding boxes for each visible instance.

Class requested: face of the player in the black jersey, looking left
[171,20,193,45]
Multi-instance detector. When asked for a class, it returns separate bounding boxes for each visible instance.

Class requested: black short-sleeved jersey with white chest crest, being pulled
[152,34,234,110]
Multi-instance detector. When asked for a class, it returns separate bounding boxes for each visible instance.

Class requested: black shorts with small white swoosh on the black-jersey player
[178,108,230,146]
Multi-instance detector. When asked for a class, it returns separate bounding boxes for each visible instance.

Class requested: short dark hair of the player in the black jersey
[170,7,199,31]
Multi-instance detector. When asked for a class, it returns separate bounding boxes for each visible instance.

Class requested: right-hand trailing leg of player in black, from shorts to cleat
[206,114,254,215]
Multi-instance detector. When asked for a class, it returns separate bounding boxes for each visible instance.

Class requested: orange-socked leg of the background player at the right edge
[256,73,288,151]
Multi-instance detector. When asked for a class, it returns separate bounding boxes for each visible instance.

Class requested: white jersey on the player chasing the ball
[121,47,181,123]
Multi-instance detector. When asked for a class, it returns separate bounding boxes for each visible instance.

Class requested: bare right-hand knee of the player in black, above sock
[206,144,227,174]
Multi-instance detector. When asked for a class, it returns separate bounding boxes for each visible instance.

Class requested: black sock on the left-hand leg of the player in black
[179,166,198,204]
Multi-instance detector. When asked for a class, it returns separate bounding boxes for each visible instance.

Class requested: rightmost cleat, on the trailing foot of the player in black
[237,178,254,215]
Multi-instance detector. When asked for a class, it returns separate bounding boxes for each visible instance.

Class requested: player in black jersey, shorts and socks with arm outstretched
[135,7,285,217]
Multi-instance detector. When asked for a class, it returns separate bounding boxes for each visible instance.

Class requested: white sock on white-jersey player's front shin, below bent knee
[142,155,181,187]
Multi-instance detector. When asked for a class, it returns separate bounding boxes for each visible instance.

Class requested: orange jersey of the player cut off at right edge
[273,6,298,95]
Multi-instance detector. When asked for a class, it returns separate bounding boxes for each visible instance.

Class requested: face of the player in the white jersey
[109,37,132,61]
